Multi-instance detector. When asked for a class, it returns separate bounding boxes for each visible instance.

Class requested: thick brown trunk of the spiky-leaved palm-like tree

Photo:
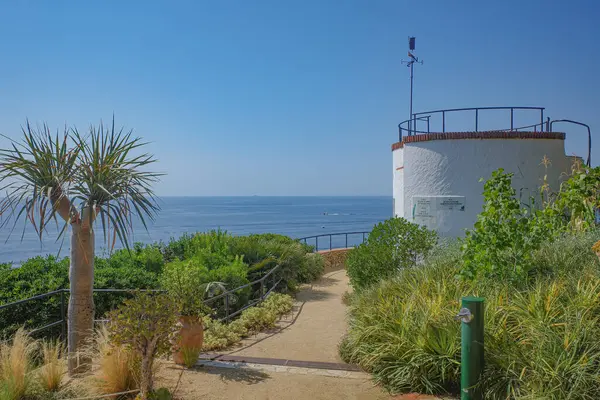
[68,220,95,375]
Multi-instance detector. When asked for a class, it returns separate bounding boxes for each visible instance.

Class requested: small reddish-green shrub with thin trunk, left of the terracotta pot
[108,293,177,400]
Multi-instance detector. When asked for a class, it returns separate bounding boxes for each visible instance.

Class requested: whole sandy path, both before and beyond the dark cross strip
[157,270,448,400]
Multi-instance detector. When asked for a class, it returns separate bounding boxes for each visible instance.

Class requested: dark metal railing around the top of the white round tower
[398,107,550,141]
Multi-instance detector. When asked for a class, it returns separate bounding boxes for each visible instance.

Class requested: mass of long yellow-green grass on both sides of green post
[340,232,600,400]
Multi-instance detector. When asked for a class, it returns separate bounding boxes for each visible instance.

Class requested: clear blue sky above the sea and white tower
[0,0,600,196]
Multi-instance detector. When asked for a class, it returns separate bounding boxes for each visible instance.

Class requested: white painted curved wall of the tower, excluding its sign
[393,139,570,237]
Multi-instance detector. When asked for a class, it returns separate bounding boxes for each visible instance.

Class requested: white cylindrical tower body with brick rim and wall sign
[392,131,572,237]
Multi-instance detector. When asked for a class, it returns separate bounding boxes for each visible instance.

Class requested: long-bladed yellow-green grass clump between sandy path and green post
[340,246,468,393]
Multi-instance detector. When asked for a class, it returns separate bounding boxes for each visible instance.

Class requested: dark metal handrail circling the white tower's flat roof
[398,106,549,141]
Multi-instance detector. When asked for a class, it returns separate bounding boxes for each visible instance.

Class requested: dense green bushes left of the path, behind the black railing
[0,231,310,336]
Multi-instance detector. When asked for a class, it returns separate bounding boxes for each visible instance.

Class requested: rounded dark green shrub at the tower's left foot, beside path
[346,218,437,290]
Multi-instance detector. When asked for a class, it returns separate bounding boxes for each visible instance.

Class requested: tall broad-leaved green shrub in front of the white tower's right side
[460,168,600,283]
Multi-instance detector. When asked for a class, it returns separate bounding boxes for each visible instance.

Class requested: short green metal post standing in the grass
[460,297,484,400]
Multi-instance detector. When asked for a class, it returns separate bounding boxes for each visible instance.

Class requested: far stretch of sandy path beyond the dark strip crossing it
[226,270,349,363]
